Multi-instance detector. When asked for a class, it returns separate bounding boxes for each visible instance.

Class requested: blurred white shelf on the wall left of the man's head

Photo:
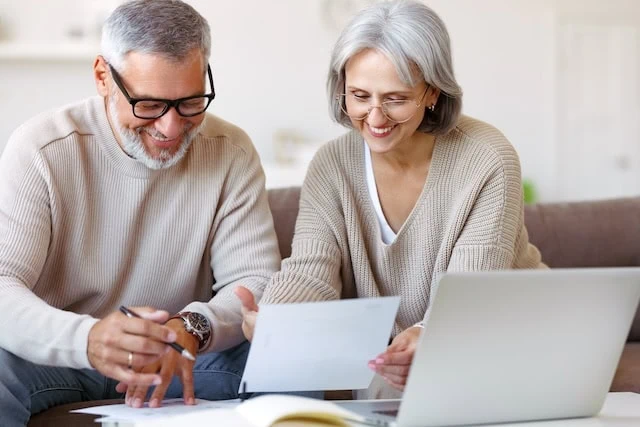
[0,41,100,62]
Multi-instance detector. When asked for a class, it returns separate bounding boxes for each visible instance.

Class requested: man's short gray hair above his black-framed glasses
[102,0,211,72]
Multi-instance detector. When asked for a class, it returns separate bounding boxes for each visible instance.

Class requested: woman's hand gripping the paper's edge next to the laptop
[369,326,422,391]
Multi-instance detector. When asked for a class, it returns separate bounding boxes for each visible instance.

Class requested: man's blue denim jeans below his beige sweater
[0,341,249,427]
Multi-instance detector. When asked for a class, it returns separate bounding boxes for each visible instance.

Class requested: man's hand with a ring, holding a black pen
[87,307,176,392]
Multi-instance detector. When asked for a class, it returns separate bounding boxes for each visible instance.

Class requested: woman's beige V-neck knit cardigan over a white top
[262,117,544,396]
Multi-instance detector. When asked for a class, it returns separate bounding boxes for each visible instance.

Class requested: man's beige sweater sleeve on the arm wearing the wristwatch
[184,136,280,351]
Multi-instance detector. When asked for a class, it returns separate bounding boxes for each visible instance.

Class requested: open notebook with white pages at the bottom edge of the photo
[125,394,376,427]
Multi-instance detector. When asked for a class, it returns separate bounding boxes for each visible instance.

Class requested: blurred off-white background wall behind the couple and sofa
[0,0,640,201]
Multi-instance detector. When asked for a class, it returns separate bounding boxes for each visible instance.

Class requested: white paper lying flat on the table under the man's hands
[71,398,240,422]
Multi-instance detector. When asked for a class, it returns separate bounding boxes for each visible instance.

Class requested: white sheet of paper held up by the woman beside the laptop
[240,297,400,392]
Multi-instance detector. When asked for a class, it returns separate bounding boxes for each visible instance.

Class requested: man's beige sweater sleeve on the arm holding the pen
[0,120,97,368]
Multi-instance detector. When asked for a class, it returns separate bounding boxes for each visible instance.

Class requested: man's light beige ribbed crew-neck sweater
[0,97,280,368]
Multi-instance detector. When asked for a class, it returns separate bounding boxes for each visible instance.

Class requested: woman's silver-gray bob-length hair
[327,0,462,135]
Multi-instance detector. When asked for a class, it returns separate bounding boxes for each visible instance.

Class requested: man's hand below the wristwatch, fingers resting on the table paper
[116,319,198,408]
